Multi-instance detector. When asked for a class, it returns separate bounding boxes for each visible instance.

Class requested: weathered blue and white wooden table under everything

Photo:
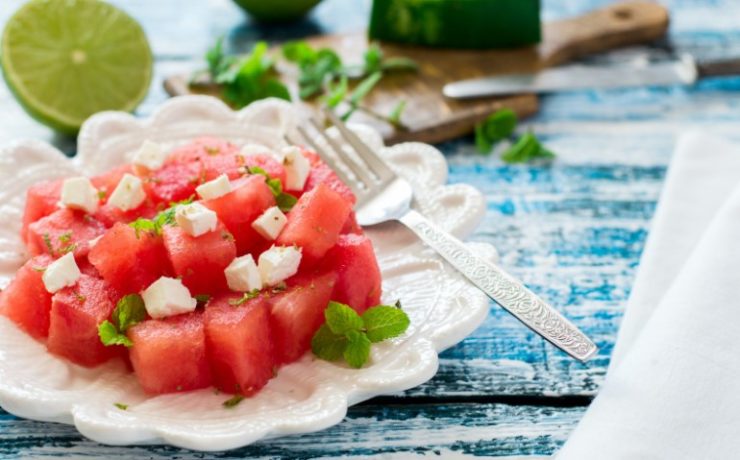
[0,0,740,459]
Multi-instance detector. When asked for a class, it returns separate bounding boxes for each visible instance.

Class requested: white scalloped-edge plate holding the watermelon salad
[0,96,496,451]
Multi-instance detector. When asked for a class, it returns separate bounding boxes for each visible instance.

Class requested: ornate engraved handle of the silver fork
[399,211,597,361]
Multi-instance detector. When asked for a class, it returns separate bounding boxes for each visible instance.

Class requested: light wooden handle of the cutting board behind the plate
[539,0,668,67]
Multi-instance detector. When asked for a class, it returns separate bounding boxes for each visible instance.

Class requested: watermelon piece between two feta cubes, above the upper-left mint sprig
[144,162,205,206]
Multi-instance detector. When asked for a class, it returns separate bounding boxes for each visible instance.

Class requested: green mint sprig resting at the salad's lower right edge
[311,302,410,369]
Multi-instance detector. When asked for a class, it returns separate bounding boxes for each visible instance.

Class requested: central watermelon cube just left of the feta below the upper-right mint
[203,174,275,254]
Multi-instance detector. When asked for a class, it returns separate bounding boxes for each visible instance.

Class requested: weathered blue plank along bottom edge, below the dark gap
[0,403,583,459]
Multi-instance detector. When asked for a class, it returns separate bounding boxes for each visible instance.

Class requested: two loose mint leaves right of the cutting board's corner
[475,109,555,164]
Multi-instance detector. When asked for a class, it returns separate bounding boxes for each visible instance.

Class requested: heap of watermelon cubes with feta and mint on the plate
[0,138,409,398]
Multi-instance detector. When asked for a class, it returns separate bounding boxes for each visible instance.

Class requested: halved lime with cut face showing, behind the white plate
[0,0,152,134]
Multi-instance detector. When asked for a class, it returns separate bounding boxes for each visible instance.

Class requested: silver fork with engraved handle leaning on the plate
[288,110,597,361]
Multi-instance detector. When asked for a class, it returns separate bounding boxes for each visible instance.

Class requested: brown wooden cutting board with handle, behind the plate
[164,1,668,143]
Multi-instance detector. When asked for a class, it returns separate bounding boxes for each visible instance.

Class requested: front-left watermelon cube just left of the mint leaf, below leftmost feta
[47,274,123,367]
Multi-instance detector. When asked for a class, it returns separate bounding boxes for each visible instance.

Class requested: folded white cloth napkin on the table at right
[556,133,740,460]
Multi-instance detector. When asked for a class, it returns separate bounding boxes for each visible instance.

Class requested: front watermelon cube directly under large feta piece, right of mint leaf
[128,311,211,394]
